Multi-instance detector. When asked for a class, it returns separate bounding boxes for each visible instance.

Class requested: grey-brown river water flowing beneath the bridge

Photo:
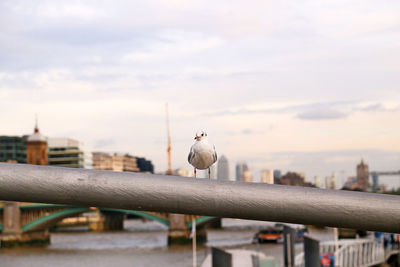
[0,219,300,267]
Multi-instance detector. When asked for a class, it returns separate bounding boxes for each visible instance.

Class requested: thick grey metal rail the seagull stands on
[0,163,400,233]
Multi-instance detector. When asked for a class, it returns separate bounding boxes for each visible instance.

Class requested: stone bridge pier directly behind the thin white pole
[168,213,207,246]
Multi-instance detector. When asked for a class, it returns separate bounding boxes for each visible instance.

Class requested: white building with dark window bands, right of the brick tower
[48,138,93,169]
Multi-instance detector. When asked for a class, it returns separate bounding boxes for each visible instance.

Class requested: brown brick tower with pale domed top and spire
[26,119,48,165]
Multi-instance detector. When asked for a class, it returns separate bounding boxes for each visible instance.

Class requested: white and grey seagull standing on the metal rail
[188,131,217,179]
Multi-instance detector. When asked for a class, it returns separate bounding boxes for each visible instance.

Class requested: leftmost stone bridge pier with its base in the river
[1,202,50,247]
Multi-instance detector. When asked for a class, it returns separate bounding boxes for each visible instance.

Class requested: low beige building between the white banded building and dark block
[93,152,139,172]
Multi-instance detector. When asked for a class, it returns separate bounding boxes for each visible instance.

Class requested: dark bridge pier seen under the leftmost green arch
[89,210,124,232]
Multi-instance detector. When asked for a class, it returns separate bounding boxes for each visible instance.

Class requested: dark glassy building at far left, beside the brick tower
[0,136,27,163]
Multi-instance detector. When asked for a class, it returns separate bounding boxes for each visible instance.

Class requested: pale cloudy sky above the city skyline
[0,0,400,188]
